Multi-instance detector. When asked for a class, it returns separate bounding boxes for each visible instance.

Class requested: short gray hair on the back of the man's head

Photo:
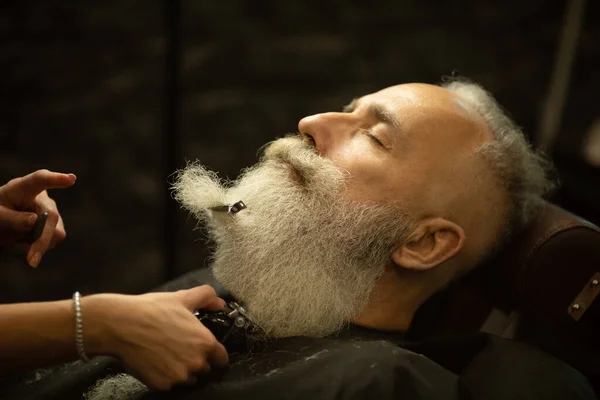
[441,78,556,237]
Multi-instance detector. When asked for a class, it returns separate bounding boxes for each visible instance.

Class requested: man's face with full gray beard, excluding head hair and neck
[174,85,492,336]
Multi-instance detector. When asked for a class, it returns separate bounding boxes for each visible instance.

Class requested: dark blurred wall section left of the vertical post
[0,0,166,301]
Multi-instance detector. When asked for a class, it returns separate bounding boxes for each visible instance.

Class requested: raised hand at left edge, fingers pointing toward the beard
[0,170,77,267]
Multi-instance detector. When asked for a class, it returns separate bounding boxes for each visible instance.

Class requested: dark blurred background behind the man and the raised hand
[0,0,600,302]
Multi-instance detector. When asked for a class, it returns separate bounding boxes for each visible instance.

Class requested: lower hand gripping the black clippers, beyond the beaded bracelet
[82,285,229,390]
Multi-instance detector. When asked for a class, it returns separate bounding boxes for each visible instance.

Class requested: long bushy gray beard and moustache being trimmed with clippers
[173,137,412,337]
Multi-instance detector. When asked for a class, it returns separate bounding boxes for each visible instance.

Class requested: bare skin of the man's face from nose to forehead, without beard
[298,84,489,215]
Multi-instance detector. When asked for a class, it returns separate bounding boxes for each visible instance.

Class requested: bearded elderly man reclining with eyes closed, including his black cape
[18,81,595,400]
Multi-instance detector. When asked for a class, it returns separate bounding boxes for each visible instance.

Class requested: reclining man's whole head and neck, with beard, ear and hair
[170,82,550,337]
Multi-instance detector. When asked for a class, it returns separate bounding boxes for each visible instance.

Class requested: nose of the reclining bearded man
[298,112,356,154]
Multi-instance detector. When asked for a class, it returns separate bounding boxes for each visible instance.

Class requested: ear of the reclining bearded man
[392,218,466,270]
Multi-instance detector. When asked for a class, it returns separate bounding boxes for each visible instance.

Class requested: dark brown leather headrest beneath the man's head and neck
[439,203,600,341]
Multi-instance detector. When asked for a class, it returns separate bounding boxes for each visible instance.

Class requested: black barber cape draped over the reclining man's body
[0,270,596,400]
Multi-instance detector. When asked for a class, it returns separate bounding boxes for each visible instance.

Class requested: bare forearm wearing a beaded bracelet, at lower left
[0,296,112,376]
